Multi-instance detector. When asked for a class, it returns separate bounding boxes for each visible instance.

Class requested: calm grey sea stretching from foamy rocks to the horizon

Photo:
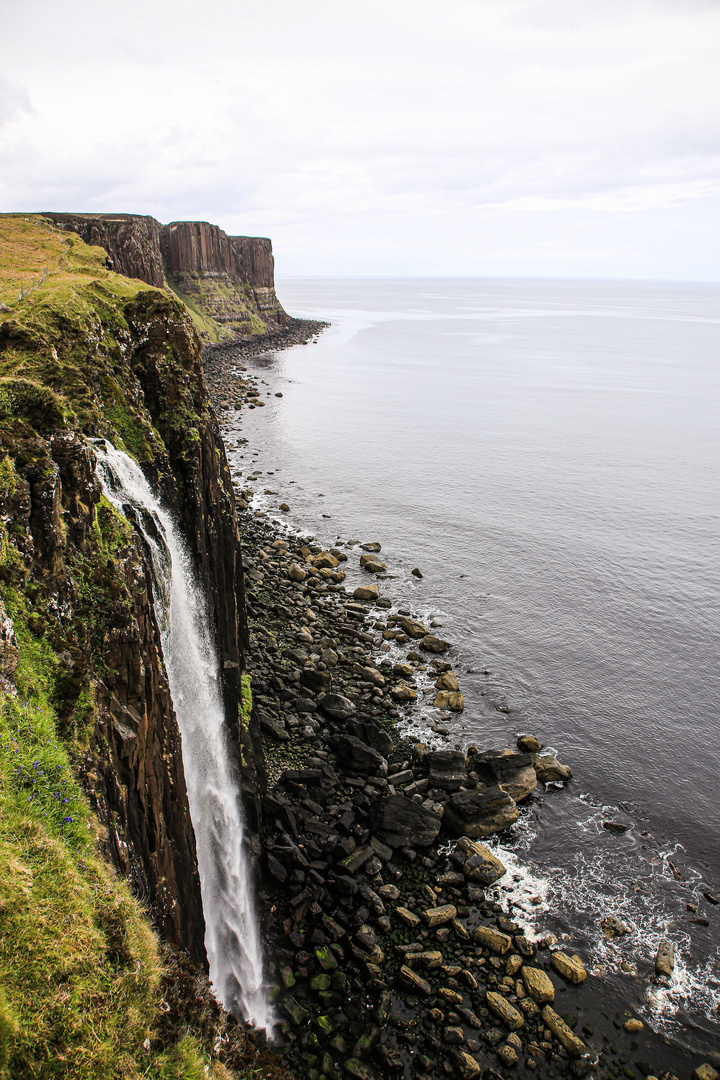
[225,281,720,1045]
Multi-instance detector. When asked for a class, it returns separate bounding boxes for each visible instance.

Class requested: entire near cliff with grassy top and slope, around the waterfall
[0,216,278,1077]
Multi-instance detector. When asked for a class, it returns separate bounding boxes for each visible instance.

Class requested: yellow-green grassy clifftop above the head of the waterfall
[0,216,185,459]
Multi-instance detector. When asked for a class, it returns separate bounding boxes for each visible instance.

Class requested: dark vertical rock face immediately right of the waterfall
[126,292,264,827]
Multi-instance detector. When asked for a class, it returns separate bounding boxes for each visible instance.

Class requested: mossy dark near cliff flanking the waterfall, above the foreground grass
[0,221,262,962]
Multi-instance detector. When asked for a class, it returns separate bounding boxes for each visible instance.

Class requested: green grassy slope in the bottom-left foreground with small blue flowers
[0,594,215,1080]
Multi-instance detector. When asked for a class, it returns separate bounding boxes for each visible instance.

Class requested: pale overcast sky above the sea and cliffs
[0,0,720,281]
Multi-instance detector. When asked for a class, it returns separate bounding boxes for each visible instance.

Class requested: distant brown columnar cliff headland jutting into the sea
[43,213,290,341]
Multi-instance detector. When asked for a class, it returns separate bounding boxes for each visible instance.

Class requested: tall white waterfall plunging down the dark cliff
[96,443,272,1028]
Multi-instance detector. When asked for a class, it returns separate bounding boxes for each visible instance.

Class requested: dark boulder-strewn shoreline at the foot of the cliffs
[205,336,717,1080]
